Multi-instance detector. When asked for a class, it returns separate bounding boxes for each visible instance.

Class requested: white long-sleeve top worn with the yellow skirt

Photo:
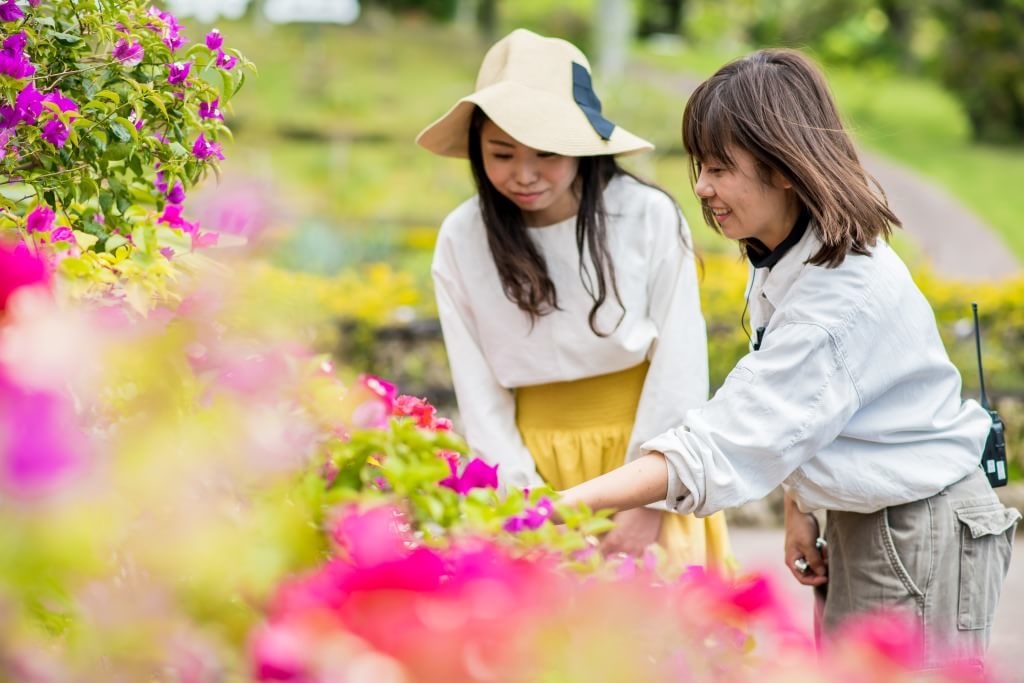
[432,176,708,486]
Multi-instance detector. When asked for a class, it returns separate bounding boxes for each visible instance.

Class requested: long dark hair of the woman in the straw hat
[469,108,667,337]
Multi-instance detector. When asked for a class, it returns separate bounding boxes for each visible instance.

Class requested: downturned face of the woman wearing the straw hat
[480,120,580,226]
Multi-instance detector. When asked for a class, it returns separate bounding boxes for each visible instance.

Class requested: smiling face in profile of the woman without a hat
[693,145,800,249]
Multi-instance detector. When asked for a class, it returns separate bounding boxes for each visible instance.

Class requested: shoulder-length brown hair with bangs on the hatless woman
[683,49,900,266]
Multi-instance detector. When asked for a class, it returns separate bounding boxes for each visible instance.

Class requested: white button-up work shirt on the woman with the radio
[643,228,991,516]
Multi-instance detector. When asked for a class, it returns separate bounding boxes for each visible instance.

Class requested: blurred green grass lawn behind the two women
[191,20,1024,270]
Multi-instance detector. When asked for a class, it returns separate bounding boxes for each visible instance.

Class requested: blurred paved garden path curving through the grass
[626,62,1024,281]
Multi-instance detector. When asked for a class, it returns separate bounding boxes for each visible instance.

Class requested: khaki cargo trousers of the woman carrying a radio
[821,469,1021,668]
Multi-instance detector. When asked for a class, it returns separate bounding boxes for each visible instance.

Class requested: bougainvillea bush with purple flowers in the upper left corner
[0,0,251,307]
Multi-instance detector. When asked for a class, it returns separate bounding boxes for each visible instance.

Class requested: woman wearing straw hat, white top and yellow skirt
[417,29,731,567]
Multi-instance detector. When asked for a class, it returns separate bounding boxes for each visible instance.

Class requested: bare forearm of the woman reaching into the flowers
[562,452,669,510]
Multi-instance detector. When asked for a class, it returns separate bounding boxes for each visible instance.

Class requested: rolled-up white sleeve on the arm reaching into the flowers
[641,323,860,516]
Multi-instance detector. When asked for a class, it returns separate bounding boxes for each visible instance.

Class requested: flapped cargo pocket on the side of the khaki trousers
[953,505,1021,631]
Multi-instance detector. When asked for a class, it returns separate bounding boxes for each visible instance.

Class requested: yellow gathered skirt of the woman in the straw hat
[516,362,735,573]
